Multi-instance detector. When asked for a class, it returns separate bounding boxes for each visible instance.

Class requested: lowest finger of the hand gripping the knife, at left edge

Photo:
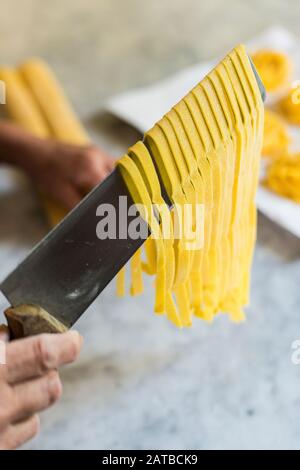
[0,415,40,450]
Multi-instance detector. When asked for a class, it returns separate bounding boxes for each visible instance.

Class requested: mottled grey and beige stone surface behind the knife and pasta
[0,0,300,449]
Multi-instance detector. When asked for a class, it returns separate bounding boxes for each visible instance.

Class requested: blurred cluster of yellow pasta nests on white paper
[252,49,300,204]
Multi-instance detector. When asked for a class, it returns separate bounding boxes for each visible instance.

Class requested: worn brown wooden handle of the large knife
[4,305,68,339]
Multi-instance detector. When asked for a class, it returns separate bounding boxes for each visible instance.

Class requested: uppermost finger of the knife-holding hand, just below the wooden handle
[6,331,83,384]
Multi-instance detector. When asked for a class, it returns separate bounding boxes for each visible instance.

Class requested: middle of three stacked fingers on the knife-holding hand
[8,370,62,422]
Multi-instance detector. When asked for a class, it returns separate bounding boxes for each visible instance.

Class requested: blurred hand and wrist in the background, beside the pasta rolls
[0,122,114,209]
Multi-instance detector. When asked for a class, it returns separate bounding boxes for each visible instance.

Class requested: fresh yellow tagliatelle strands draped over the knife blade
[118,46,264,326]
